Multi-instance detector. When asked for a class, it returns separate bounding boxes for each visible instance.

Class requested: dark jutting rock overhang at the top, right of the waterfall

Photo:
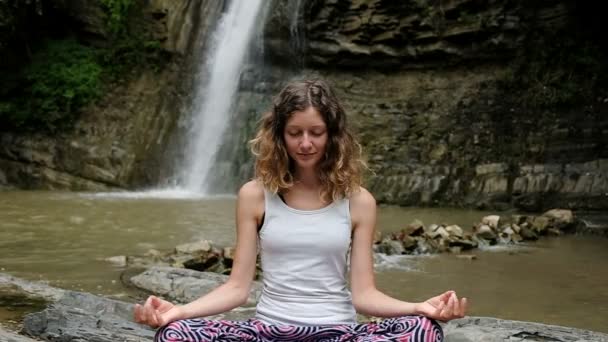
[268,0,567,69]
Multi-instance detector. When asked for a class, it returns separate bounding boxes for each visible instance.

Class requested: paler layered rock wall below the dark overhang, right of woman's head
[312,71,608,212]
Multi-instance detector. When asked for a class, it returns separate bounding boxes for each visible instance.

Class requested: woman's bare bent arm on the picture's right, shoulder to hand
[350,188,466,320]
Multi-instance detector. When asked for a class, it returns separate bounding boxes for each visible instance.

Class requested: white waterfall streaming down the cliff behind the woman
[178,0,265,194]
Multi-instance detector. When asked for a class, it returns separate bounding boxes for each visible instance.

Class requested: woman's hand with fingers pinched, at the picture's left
[133,296,180,328]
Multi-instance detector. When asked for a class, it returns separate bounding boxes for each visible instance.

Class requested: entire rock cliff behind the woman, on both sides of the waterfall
[0,0,608,211]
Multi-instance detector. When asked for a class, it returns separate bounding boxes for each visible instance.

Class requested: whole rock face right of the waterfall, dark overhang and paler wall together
[256,0,608,212]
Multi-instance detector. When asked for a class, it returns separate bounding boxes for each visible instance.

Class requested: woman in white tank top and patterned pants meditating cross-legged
[135,80,467,341]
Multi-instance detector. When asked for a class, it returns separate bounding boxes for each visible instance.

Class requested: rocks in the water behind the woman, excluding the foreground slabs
[106,209,608,280]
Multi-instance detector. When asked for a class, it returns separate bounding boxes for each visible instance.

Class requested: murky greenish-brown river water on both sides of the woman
[0,191,608,332]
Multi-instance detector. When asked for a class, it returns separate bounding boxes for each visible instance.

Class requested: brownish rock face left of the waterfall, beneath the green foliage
[0,0,222,191]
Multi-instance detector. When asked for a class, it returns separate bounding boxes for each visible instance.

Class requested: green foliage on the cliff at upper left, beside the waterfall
[0,0,164,131]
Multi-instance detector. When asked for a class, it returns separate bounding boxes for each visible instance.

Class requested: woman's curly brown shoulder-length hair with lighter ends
[249,79,366,202]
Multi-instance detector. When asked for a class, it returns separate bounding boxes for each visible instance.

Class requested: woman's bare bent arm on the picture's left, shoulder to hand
[135,181,264,326]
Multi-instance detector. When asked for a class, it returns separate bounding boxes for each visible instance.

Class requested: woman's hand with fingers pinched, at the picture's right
[416,291,468,322]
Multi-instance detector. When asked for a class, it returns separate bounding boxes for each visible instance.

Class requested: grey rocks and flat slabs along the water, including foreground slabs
[0,209,608,342]
